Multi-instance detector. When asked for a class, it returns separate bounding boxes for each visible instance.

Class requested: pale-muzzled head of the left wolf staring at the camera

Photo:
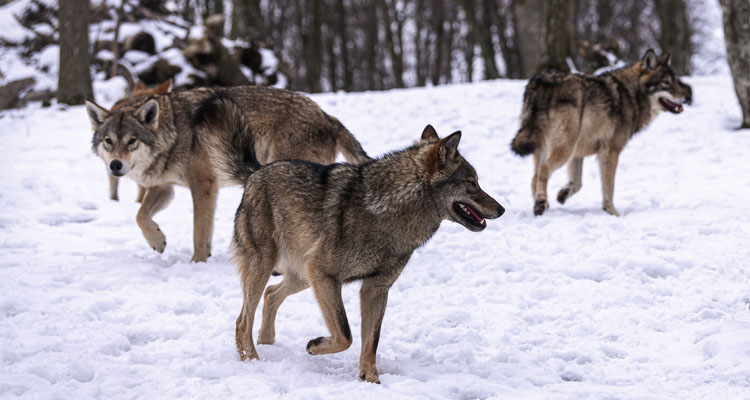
[86,98,159,176]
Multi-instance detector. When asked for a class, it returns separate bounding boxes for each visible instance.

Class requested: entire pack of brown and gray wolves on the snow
[86,50,692,383]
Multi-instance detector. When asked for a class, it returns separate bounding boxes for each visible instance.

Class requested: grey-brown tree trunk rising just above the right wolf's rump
[512,0,549,78]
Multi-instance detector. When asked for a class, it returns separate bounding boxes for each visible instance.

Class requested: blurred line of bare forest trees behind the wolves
[212,0,693,92]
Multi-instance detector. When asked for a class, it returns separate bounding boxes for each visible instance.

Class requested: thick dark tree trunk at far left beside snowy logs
[57,0,93,104]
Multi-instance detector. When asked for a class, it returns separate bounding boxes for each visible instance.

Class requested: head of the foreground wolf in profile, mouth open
[422,125,505,232]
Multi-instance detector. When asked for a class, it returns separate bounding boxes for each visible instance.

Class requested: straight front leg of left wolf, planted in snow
[190,175,219,262]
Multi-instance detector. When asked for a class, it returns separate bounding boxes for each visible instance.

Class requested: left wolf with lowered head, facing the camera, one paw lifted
[86,86,369,261]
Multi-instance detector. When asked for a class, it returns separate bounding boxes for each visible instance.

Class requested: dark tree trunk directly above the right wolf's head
[654,0,692,75]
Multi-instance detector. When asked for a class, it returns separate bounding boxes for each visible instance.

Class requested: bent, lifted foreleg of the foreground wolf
[307,268,352,355]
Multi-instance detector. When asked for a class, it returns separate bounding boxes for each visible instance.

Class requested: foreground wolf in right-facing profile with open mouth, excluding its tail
[232,126,505,382]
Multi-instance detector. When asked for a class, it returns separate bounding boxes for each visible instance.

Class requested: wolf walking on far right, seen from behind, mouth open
[511,50,692,219]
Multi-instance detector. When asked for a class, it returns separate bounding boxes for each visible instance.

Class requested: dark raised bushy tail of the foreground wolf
[192,92,260,185]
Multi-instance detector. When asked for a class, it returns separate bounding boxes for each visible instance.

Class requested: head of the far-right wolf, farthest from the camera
[639,49,693,114]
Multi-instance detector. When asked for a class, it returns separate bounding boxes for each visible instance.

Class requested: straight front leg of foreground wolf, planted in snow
[359,277,390,383]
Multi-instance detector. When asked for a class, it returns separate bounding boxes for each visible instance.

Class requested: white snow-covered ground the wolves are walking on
[0,77,750,399]
